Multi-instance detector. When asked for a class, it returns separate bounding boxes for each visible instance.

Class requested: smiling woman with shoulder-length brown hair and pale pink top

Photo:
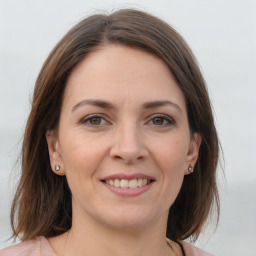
[0,10,219,256]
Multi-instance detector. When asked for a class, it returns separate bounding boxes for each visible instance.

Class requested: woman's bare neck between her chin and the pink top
[50,211,173,256]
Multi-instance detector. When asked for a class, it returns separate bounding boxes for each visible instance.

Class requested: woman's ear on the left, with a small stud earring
[45,130,65,176]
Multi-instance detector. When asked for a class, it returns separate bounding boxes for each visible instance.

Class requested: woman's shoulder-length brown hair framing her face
[11,9,219,241]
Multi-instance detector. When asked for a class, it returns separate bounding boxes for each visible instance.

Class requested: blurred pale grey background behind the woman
[0,0,256,256]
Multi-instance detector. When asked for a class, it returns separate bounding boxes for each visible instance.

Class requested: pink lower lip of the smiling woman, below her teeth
[103,182,154,197]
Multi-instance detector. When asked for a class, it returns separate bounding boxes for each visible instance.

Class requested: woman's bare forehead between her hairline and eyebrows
[64,45,185,111]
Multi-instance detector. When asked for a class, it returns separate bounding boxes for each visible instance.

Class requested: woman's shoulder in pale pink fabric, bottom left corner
[0,237,56,256]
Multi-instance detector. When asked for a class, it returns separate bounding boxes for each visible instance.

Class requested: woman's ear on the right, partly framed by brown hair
[185,133,202,175]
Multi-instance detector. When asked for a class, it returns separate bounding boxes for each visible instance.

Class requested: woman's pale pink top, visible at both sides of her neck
[0,236,213,256]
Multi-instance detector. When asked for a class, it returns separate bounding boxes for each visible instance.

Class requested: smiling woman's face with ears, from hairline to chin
[47,45,200,232]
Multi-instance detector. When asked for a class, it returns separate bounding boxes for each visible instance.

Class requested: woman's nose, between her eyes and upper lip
[110,125,148,164]
